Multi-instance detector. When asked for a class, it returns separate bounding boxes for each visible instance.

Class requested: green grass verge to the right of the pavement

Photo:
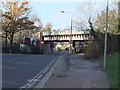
[106,54,120,88]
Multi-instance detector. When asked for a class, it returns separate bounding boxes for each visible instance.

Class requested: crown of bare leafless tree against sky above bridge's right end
[77,0,98,28]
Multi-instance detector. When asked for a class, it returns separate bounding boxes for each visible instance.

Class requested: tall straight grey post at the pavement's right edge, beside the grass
[103,0,108,69]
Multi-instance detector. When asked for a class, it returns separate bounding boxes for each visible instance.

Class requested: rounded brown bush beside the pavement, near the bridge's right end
[85,41,101,59]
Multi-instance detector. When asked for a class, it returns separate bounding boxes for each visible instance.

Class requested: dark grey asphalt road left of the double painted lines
[2,54,58,88]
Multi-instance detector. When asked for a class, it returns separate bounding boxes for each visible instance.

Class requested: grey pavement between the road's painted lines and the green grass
[42,55,109,88]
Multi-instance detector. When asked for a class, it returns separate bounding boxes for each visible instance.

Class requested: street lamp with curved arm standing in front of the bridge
[61,11,73,54]
